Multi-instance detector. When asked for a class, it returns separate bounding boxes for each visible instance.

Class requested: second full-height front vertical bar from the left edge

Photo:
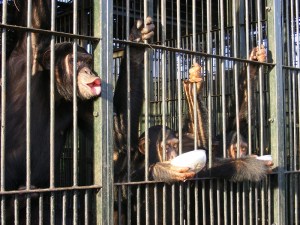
[26,0,32,225]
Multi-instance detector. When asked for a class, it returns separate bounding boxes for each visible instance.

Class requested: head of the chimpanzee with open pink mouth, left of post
[42,42,101,101]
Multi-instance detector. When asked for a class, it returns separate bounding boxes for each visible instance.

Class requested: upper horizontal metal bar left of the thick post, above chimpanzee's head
[0,23,101,42]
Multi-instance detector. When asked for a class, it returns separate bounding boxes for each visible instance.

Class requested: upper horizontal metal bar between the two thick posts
[114,40,275,67]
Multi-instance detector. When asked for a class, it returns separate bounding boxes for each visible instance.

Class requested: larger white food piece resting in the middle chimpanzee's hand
[171,149,206,173]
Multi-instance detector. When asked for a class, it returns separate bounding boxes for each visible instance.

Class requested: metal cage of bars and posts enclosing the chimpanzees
[0,0,300,225]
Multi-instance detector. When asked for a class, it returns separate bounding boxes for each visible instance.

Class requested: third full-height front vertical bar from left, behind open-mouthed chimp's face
[49,1,56,224]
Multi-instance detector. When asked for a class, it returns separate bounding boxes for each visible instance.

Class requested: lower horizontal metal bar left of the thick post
[0,185,102,196]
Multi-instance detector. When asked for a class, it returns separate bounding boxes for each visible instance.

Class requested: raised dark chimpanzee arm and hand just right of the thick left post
[114,17,155,149]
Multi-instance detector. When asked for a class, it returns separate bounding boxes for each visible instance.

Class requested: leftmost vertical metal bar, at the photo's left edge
[0,1,7,225]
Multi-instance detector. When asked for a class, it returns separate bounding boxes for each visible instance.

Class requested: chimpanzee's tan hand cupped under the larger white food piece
[150,161,195,182]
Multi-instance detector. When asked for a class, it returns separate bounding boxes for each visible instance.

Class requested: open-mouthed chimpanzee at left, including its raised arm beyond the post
[1,0,154,224]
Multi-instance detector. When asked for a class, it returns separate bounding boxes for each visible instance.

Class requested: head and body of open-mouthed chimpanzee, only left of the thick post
[1,0,101,224]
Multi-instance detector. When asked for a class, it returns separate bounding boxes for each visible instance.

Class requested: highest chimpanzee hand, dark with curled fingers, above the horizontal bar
[129,16,155,42]
